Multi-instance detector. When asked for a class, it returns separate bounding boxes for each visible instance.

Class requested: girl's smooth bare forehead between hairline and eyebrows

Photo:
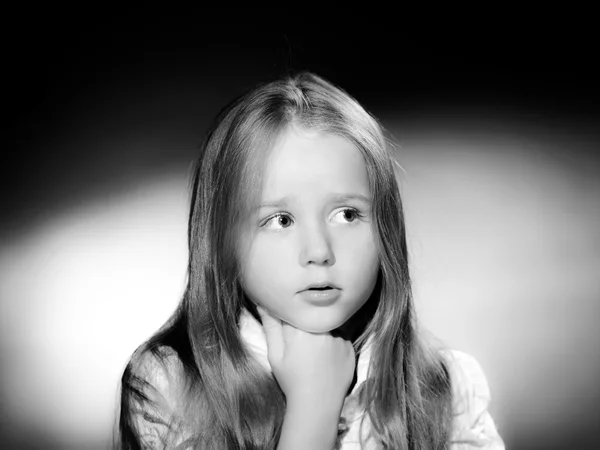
[262,127,369,199]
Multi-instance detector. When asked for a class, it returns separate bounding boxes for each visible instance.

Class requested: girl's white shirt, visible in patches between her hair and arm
[133,310,504,450]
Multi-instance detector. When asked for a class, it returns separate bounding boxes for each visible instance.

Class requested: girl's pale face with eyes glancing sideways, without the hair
[239,128,379,333]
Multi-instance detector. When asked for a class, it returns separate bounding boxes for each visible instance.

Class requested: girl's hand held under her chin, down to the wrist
[257,306,356,406]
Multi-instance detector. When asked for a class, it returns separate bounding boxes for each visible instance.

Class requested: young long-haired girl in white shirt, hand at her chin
[119,73,504,450]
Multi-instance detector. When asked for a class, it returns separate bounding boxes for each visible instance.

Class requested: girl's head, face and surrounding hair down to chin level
[189,73,409,348]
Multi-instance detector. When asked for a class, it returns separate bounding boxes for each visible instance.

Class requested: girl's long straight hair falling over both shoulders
[120,72,450,449]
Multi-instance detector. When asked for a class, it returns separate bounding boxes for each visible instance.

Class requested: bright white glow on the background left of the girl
[0,173,188,445]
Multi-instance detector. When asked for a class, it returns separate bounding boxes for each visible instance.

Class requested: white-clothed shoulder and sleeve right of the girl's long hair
[443,350,504,450]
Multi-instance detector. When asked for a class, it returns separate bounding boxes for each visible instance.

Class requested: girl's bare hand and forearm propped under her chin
[258,307,356,450]
